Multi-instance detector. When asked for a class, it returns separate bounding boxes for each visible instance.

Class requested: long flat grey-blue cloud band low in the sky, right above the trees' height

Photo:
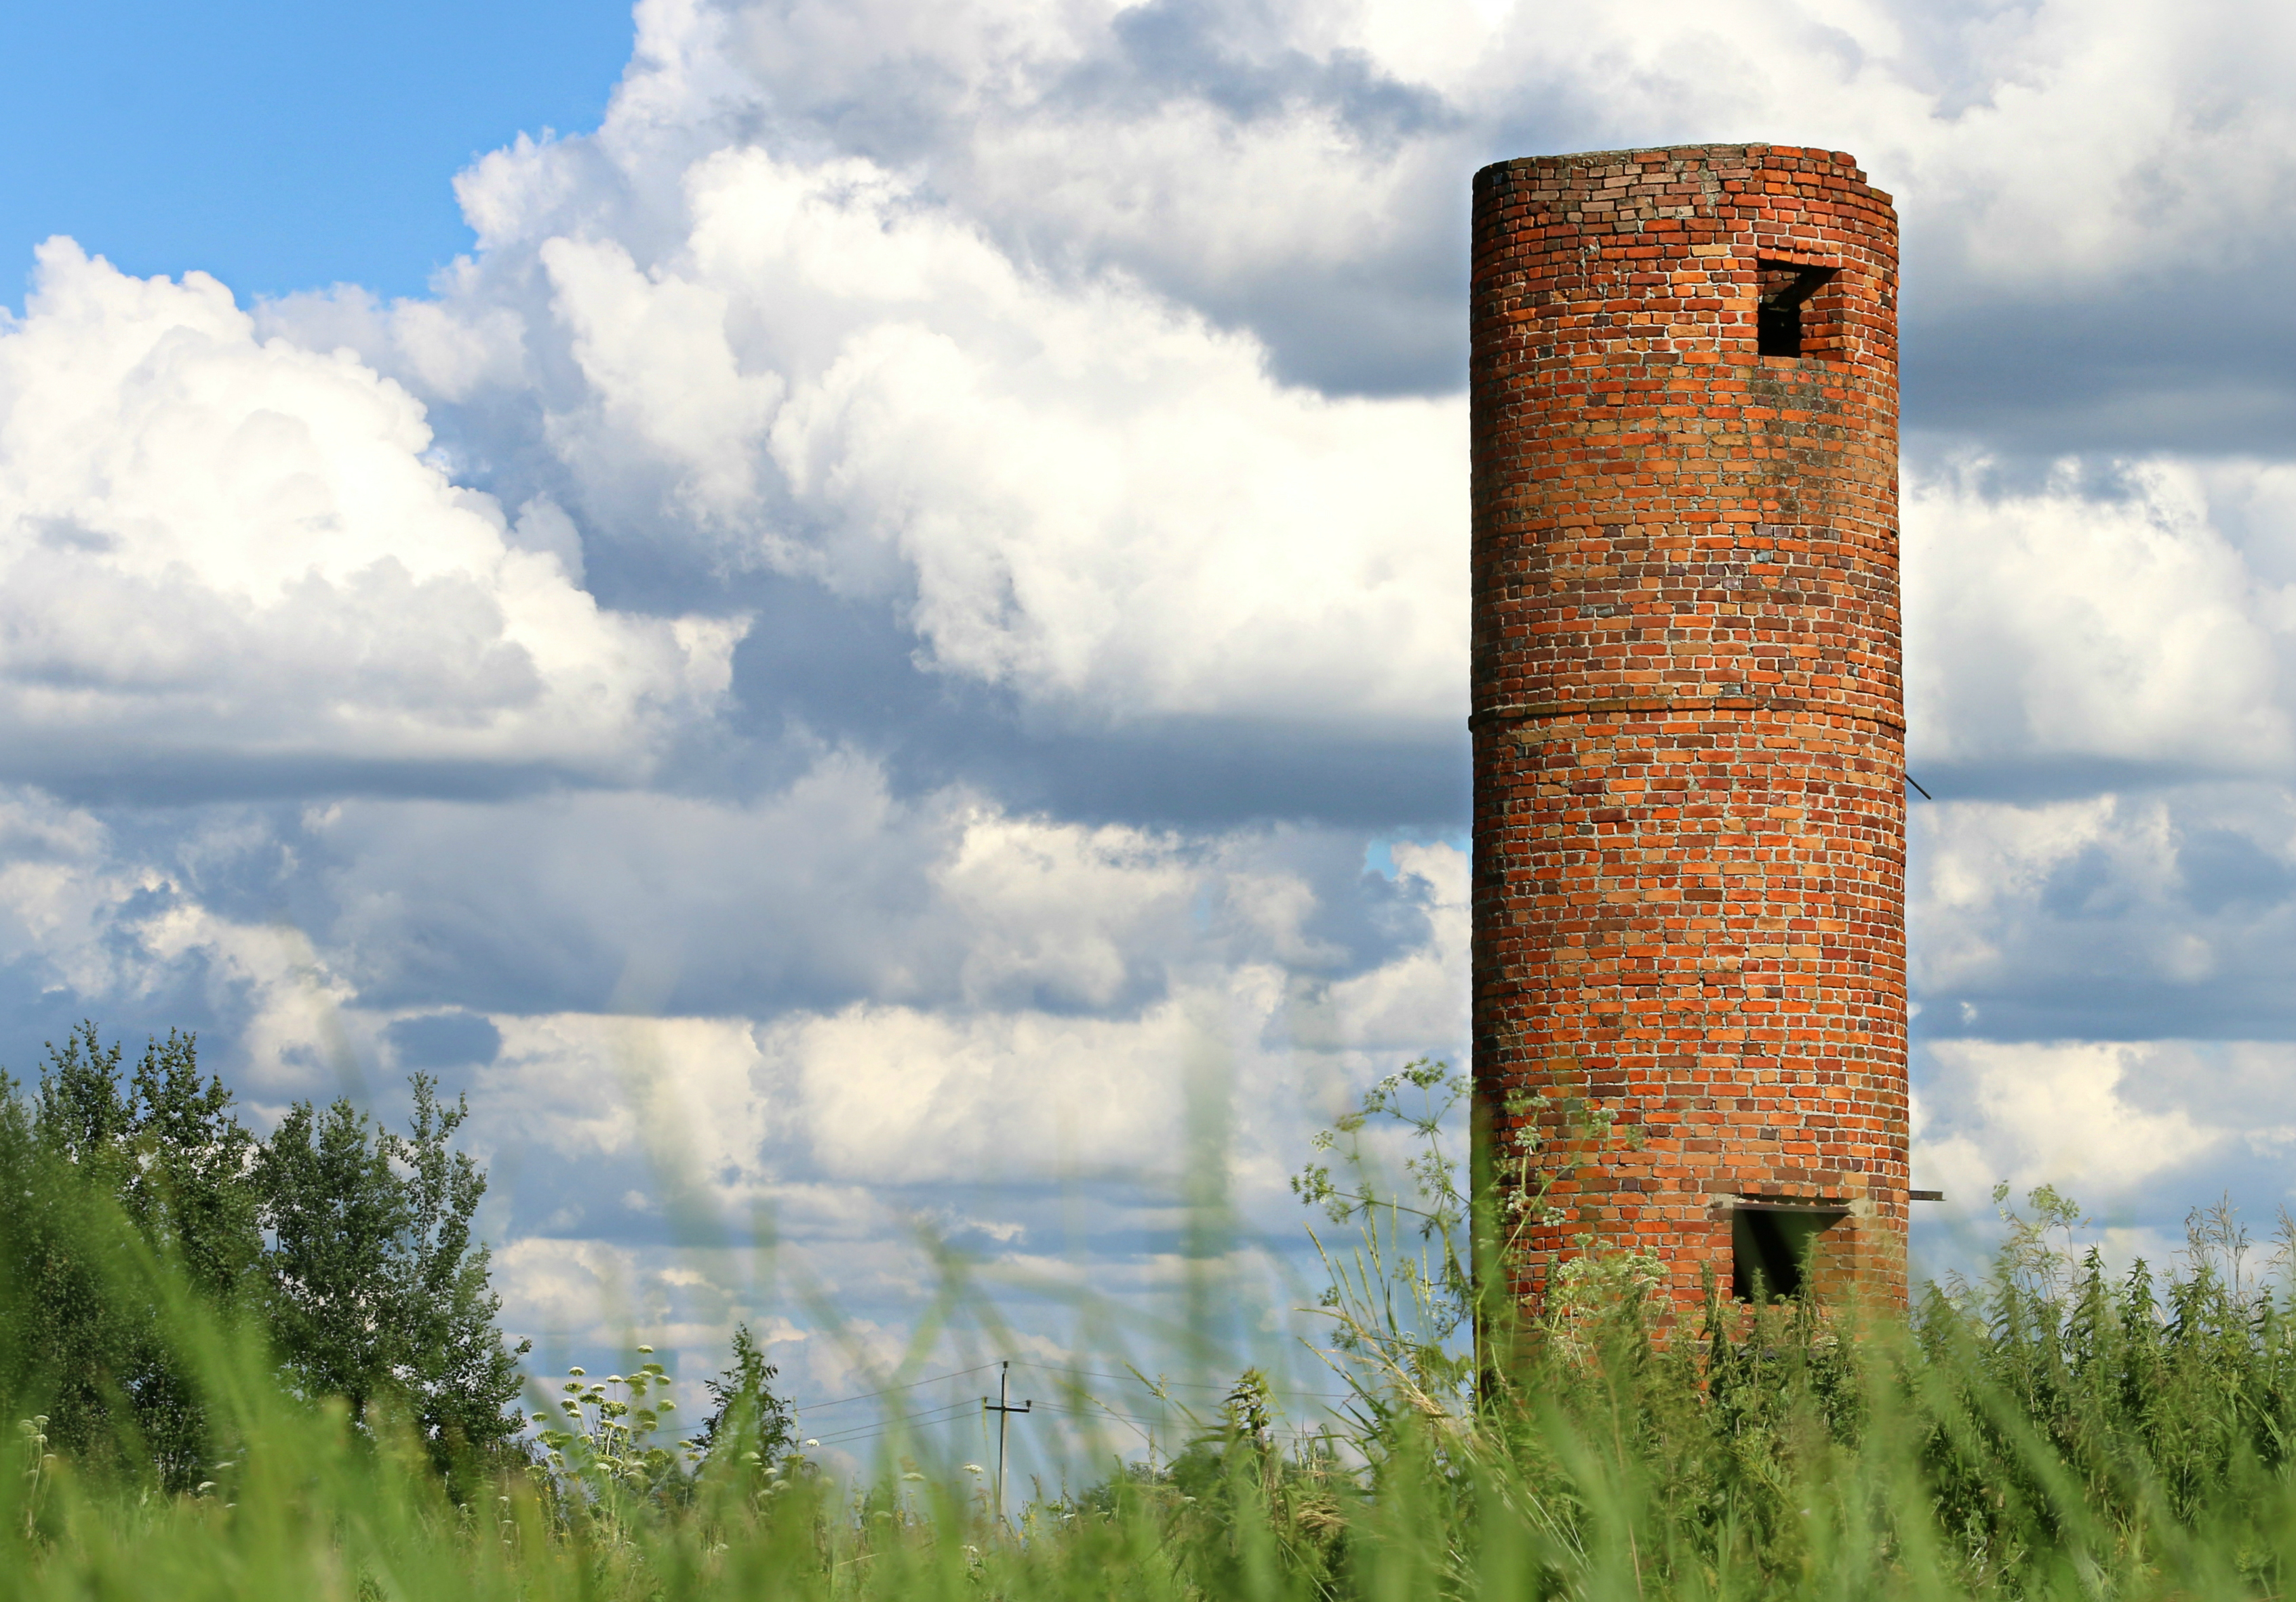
[298,753,1219,1017]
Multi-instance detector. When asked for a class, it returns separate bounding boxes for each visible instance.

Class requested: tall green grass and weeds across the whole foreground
[0,1068,2296,1602]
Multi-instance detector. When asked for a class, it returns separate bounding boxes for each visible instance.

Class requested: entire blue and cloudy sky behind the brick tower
[0,0,2296,1468]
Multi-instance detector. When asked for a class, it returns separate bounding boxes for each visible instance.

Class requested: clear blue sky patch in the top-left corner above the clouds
[0,0,631,300]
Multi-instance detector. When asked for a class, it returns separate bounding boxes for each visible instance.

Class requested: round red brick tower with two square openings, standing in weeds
[1471,144,1908,1304]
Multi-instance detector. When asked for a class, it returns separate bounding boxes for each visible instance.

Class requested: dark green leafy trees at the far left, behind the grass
[0,1023,523,1492]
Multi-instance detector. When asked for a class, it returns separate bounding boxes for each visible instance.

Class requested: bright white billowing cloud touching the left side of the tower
[360,136,1465,725]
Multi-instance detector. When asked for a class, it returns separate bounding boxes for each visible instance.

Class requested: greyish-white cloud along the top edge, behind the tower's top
[512,0,2296,425]
